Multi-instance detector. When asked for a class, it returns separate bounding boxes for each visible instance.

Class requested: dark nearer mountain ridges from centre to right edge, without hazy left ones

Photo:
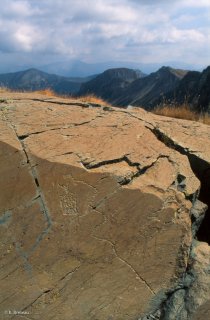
[78,67,210,112]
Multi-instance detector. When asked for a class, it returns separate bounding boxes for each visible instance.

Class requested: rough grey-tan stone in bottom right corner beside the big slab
[164,241,210,320]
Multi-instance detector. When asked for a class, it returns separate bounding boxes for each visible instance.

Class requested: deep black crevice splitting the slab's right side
[150,127,210,244]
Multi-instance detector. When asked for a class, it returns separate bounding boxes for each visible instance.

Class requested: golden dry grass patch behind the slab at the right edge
[153,103,210,125]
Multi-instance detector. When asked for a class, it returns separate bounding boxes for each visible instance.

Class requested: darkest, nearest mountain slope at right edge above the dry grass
[165,66,210,112]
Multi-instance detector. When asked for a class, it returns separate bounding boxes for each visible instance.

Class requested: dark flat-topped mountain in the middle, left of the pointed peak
[78,68,144,103]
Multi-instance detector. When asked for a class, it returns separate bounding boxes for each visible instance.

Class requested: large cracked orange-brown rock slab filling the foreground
[0,93,210,320]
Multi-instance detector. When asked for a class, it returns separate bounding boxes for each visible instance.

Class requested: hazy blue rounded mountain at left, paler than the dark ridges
[0,69,92,94]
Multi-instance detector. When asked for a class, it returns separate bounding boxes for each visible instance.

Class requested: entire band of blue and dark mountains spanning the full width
[0,67,210,112]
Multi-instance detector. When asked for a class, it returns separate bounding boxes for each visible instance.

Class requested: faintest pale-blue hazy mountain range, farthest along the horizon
[0,56,204,77]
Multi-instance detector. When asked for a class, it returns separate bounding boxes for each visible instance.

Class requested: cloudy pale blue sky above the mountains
[0,0,210,71]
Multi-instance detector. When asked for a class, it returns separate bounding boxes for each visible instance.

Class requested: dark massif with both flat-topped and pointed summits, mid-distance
[79,67,187,109]
